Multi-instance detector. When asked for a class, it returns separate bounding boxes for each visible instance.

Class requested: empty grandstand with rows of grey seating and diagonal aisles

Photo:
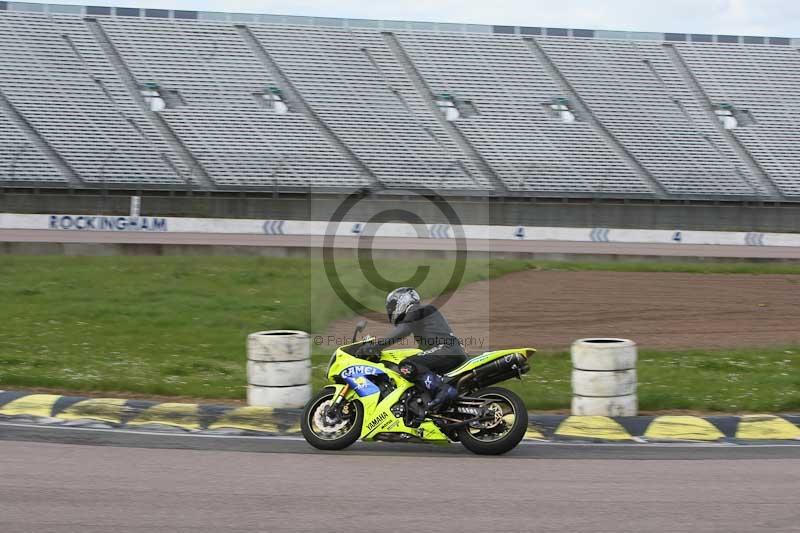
[0,2,800,218]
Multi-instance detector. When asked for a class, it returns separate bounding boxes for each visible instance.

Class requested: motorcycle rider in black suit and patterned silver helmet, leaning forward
[356,287,467,411]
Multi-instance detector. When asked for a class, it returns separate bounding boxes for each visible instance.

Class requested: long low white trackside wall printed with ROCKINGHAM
[0,213,800,247]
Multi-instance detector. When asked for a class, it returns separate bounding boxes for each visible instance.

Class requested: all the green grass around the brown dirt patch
[0,256,800,411]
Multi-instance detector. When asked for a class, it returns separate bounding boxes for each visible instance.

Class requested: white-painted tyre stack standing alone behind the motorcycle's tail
[572,338,638,416]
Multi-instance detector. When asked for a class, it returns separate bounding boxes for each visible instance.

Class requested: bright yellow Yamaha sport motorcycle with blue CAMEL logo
[300,321,536,455]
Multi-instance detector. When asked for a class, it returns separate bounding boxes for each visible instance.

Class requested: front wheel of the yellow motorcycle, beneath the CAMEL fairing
[300,388,364,450]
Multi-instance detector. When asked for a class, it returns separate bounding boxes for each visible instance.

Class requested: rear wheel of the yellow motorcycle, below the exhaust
[458,387,528,455]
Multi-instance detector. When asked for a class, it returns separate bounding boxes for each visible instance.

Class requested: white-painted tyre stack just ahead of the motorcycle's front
[247,330,311,407]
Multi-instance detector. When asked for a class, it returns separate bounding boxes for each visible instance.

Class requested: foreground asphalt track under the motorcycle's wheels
[0,424,800,533]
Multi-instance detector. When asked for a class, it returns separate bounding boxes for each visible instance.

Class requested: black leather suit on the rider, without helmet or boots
[376,304,467,381]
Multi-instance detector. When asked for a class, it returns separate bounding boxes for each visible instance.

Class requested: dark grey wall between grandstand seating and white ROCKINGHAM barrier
[0,189,800,233]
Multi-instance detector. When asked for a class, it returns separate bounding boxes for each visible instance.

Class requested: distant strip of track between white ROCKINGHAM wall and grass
[0,229,800,259]
